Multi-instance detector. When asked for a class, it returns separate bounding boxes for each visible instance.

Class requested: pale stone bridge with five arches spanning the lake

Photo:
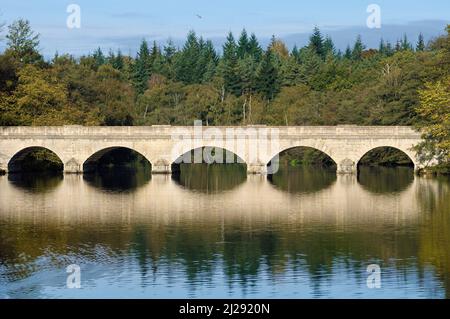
[0,125,421,174]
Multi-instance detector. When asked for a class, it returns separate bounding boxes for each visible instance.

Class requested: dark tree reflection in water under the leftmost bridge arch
[8,172,64,193]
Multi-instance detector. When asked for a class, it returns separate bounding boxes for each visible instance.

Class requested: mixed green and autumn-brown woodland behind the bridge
[0,19,450,171]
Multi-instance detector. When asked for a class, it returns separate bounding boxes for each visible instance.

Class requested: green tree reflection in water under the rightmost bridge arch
[358,166,414,194]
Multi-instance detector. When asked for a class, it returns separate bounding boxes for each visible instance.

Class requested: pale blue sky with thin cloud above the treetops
[0,0,450,56]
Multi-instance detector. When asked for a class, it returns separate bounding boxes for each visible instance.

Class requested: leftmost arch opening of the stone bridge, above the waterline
[7,145,64,173]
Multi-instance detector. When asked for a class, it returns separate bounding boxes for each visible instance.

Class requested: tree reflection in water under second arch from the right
[268,165,336,193]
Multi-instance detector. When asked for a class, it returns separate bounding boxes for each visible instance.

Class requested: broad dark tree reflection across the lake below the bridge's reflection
[0,220,428,296]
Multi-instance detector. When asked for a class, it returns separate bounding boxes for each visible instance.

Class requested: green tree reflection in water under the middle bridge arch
[173,164,247,193]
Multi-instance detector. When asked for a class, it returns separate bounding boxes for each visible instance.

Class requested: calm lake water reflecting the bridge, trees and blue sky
[0,165,450,298]
